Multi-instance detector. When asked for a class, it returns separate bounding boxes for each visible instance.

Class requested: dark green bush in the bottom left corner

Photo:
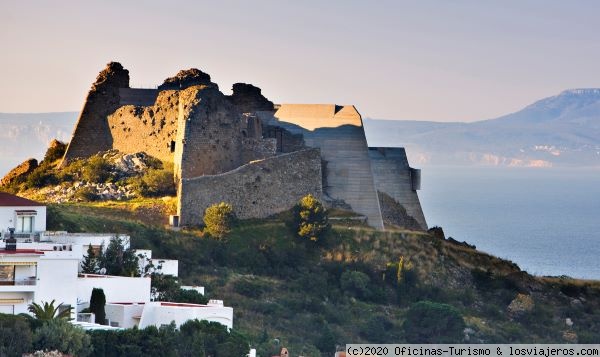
[0,314,32,357]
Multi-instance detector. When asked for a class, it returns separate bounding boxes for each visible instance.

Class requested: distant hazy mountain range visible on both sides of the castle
[0,89,600,176]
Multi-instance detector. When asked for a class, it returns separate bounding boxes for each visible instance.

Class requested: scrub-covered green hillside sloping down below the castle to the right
[41,200,600,355]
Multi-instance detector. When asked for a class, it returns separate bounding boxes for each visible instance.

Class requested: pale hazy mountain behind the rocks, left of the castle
[0,112,78,176]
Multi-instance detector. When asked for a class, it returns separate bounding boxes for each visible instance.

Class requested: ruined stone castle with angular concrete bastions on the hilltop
[63,62,427,229]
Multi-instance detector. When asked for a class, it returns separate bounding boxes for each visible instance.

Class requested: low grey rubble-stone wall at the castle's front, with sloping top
[178,149,322,225]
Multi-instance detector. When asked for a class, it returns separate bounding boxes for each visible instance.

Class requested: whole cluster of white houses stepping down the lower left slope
[0,193,233,329]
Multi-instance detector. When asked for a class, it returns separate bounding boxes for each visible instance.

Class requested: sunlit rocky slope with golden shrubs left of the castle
[0,140,175,203]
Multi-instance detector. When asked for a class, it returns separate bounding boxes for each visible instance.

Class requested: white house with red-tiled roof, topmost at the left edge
[0,192,46,238]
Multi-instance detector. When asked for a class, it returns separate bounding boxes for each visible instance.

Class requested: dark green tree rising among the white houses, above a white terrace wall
[100,236,139,276]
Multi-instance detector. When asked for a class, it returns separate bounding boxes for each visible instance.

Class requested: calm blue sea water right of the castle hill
[419,167,600,279]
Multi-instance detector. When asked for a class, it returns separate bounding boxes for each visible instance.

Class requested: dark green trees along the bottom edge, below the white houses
[90,320,249,357]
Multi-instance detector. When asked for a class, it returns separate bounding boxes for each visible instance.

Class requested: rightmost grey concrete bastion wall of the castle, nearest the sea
[369,148,427,229]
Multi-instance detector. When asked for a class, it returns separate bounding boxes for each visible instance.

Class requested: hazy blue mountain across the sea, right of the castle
[365,89,600,166]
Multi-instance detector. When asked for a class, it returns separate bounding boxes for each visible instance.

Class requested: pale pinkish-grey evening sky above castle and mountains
[0,0,600,121]
